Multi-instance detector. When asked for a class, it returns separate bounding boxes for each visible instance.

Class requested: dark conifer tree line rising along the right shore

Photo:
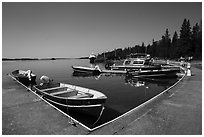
[97,19,202,60]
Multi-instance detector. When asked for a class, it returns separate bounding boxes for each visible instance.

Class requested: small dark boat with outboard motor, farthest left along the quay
[11,70,36,84]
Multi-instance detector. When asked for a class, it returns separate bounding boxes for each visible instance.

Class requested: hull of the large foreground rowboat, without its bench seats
[33,83,107,116]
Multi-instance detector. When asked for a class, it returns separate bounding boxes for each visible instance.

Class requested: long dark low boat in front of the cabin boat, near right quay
[128,69,180,77]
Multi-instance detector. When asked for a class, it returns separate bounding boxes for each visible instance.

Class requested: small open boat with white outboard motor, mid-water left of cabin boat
[72,66,101,75]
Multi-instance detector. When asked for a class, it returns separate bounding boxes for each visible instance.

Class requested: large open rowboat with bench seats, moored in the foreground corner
[33,83,107,117]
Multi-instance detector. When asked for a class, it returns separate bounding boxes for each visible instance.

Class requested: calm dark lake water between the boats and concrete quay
[2,59,178,128]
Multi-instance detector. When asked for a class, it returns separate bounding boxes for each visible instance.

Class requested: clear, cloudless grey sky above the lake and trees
[2,2,202,58]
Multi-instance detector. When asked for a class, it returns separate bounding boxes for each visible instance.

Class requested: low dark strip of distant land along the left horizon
[2,57,89,61]
